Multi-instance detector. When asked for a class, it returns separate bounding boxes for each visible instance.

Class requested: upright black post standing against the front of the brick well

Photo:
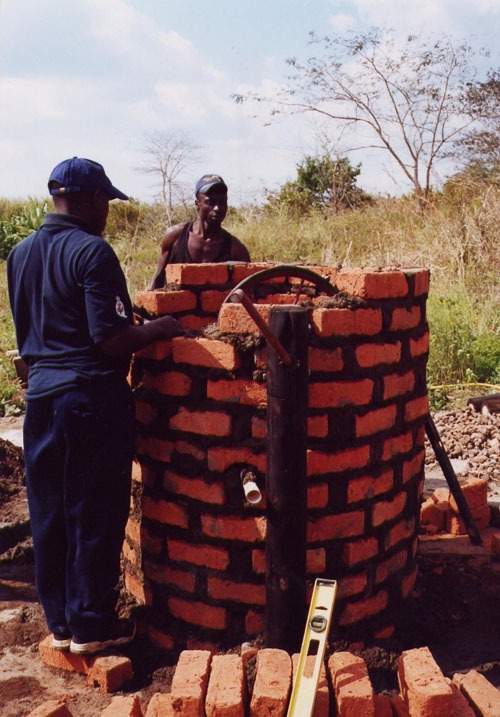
[266,305,308,653]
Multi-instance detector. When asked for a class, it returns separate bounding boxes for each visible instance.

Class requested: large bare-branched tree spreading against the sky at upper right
[235,28,488,202]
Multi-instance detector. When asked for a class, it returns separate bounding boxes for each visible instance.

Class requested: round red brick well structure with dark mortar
[124,264,429,651]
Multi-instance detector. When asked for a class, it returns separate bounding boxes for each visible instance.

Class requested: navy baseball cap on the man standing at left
[48,157,128,199]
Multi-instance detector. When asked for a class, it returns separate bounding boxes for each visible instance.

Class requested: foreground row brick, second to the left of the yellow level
[205,655,245,717]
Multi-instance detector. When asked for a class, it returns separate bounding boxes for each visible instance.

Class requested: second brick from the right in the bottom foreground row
[398,647,453,717]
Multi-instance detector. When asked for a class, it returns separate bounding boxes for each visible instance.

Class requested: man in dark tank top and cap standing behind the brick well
[149,174,250,289]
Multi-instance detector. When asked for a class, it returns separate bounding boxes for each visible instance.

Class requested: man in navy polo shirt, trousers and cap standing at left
[7,157,183,654]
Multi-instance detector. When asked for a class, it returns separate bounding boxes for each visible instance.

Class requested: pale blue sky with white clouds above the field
[0,0,500,204]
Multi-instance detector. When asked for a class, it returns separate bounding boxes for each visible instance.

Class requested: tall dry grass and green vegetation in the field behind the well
[0,172,500,414]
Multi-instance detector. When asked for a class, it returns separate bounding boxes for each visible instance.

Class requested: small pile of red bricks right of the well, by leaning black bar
[420,477,491,535]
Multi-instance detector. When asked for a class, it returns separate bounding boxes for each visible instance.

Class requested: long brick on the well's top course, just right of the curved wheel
[335,269,408,299]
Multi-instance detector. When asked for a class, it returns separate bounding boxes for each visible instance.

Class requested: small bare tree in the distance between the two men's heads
[139,130,201,220]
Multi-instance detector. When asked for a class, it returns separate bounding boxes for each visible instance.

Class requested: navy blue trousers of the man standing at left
[24,380,133,642]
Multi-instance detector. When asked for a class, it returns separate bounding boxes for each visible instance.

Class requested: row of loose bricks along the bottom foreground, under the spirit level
[28,647,500,717]
